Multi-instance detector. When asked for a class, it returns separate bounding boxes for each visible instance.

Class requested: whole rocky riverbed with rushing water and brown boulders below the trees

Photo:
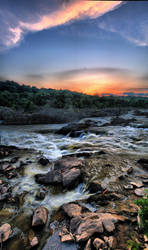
[0,110,148,250]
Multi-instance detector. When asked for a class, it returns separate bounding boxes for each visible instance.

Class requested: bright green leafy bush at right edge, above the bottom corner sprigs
[135,190,148,236]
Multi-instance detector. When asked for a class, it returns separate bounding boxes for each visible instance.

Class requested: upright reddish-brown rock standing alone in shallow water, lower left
[32,207,48,227]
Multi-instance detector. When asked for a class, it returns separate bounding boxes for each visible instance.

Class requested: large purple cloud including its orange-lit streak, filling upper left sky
[0,0,122,50]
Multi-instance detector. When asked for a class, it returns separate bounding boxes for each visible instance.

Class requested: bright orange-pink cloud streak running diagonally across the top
[9,0,122,45]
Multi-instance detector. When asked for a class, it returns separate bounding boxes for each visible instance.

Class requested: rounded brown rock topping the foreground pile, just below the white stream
[62,203,82,218]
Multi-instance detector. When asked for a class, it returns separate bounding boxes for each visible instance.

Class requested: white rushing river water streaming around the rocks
[0,112,148,249]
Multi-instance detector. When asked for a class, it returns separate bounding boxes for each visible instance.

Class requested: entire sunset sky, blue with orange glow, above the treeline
[0,0,148,96]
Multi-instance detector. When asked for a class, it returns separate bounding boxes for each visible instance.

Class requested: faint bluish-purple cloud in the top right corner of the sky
[98,1,148,46]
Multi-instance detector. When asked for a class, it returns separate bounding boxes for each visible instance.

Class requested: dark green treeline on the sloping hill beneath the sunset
[0,81,148,111]
